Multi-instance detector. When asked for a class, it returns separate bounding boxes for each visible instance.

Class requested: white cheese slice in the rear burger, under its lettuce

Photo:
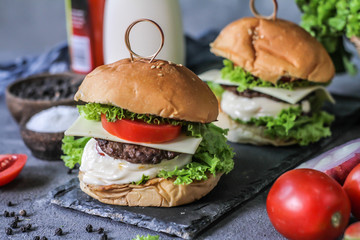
[199,69,335,104]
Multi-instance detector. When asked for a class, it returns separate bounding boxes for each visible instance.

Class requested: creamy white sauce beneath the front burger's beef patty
[80,138,192,185]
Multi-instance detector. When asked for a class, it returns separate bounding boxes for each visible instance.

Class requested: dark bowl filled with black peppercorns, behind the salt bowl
[5,73,84,123]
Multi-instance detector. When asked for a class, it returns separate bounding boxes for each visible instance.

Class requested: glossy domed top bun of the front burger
[75,59,218,123]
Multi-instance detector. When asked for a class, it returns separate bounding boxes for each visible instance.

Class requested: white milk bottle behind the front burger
[103,0,185,64]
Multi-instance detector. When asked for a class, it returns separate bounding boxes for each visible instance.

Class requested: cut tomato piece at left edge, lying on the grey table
[0,154,27,186]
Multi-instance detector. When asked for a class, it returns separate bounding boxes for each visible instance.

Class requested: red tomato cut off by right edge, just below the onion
[343,164,360,220]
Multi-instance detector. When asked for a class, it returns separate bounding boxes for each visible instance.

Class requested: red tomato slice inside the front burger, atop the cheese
[101,114,181,143]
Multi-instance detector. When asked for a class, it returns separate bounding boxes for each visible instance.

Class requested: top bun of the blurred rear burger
[210,18,335,84]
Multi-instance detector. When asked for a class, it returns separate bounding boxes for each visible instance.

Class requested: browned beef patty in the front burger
[96,139,180,164]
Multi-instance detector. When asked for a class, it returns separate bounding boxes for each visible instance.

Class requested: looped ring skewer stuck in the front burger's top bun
[125,18,165,63]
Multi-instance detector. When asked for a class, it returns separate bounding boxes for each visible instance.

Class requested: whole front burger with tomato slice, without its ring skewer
[62,59,234,207]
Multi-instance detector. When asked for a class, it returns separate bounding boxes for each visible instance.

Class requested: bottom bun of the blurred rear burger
[214,112,297,147]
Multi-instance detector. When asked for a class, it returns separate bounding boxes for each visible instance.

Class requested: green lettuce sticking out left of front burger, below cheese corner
[61,136,91,169]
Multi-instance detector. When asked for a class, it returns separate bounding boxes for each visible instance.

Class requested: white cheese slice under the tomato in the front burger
[65,116,202,154]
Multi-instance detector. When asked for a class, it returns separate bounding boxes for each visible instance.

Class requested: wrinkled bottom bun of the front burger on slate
[79,171,222,207]
